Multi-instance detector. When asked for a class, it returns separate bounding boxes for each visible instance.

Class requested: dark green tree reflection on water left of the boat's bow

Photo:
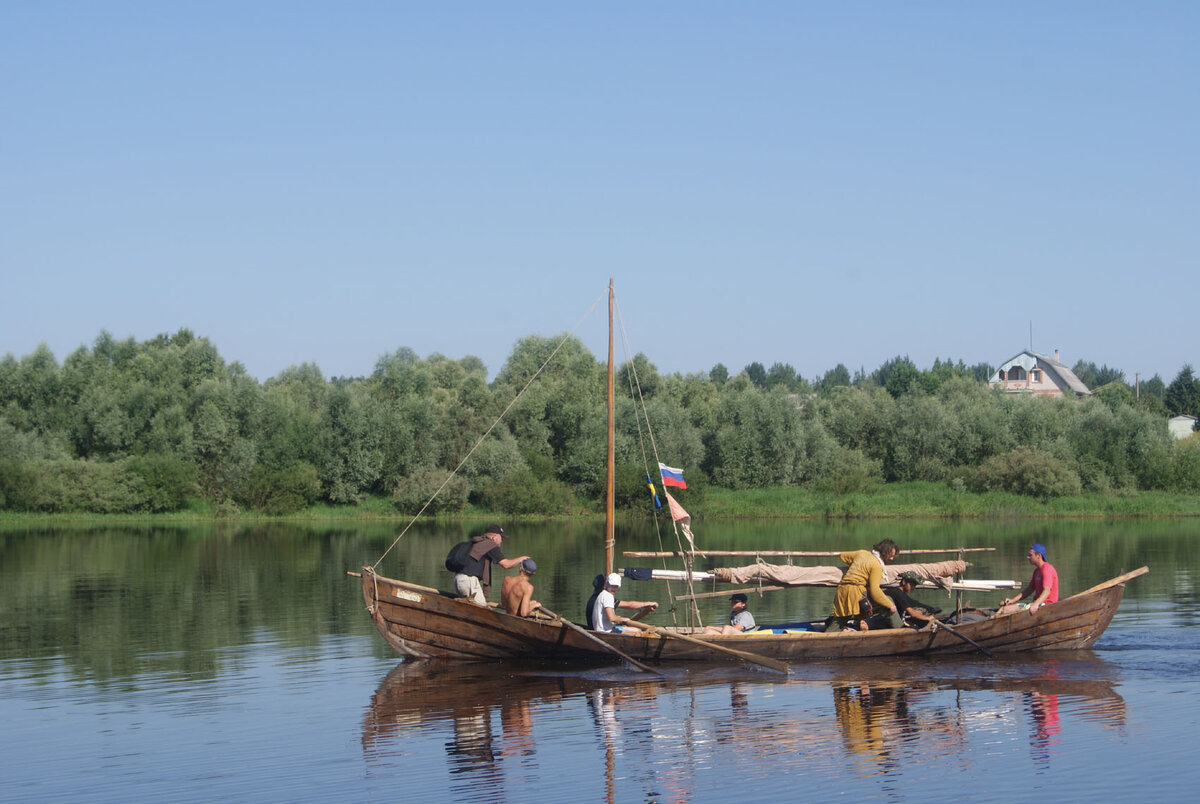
[0,524,408,682]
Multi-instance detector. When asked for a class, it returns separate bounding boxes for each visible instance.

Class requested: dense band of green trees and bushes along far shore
[0,329,1200,514]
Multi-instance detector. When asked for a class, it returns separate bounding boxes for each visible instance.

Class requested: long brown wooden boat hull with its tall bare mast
[354,281,1148,670]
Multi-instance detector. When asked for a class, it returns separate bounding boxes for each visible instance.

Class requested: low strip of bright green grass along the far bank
[0,482,1200,527]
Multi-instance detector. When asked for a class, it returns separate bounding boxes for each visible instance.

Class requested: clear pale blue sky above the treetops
[0,0,1200,383]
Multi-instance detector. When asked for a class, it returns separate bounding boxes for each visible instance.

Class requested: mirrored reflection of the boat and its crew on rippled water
[362,652,1126,800]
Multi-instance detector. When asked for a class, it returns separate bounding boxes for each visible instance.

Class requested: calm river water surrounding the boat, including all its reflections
[0,521,1200,804]
